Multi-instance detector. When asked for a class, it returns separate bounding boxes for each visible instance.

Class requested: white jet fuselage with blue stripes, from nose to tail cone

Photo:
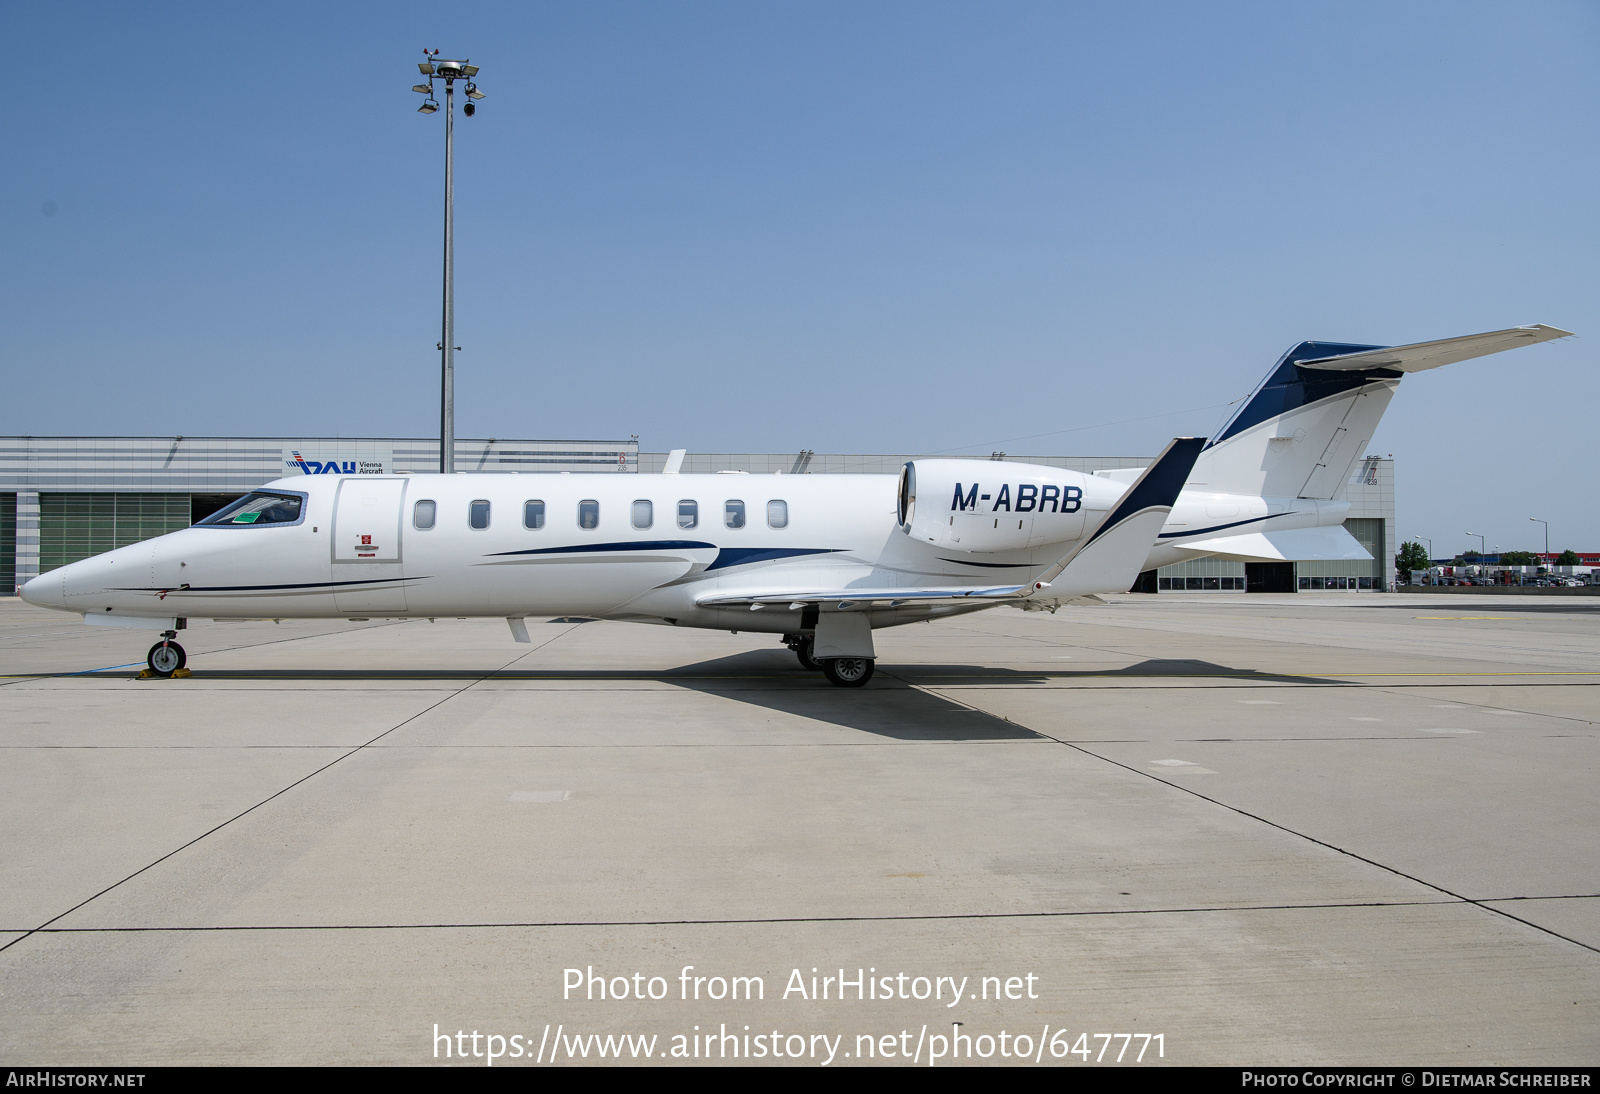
[27,462,1342,633]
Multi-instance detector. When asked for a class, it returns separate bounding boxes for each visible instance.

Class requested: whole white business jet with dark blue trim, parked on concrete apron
[22,325,1568,688]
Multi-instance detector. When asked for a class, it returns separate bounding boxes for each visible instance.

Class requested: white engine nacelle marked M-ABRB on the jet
[898,459,1100,553]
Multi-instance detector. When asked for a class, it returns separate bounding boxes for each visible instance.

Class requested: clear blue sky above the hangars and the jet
[0,2,1600,553]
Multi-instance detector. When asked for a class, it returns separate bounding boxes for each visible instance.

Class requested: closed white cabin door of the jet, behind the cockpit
[333,475,406,616]
